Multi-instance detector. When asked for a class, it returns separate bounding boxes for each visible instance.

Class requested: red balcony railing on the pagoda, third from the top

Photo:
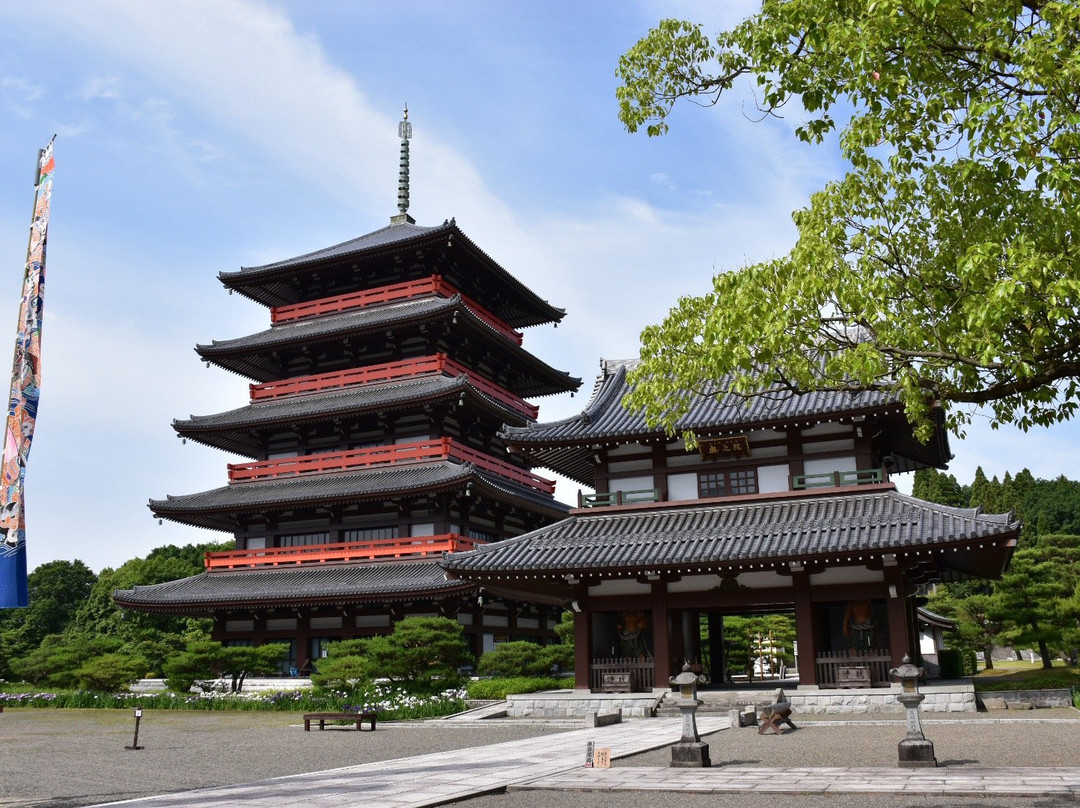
[228,437,555,494]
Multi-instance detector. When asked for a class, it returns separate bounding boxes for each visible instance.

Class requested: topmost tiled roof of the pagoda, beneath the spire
[218,220,566,328]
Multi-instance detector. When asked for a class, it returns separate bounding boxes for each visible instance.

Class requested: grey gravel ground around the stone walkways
[0,709,1080,808]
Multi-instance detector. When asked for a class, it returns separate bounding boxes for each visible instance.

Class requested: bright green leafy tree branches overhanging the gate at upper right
[617,0,1080,439]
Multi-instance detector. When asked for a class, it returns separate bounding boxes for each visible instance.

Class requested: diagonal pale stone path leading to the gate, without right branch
[90,717,727,808]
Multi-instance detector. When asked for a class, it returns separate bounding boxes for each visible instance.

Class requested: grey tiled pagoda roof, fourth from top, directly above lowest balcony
[149,461,567,533]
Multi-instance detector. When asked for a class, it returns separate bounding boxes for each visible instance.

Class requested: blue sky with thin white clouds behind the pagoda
[0,0,1067,570]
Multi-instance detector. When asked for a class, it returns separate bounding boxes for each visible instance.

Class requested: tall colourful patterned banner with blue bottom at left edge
[0,140,53,608]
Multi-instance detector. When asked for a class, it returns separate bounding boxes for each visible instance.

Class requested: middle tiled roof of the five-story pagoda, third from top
[173,376,528,457]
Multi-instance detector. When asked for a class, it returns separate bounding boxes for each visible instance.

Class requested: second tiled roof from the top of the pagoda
[195,295,581,398]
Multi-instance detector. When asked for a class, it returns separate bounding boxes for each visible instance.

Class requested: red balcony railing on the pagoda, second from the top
[248,353,540,420]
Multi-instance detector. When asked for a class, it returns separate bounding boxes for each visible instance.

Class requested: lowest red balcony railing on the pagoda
[203,533,486,573]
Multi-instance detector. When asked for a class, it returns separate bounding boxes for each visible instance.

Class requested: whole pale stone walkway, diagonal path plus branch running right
[88,717,1080,808]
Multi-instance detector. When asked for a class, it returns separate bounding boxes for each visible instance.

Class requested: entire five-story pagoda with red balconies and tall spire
[114,110,580,670]
